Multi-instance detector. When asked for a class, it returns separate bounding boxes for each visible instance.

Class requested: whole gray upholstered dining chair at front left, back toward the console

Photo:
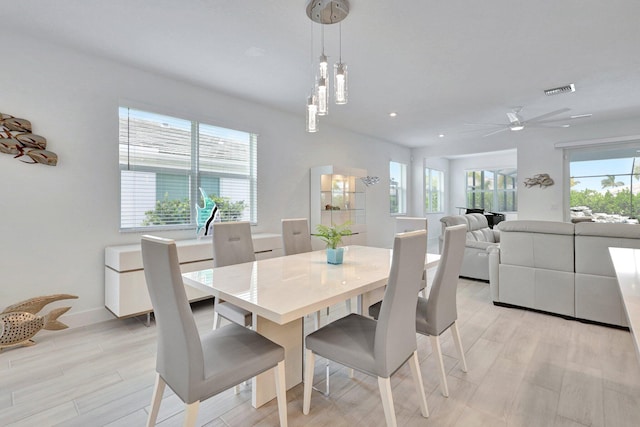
[142,236,287,426]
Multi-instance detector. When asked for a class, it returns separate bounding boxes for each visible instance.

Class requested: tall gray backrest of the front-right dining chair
[374,230,427,378]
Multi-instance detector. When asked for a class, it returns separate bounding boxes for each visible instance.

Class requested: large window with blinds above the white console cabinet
[119,107,257,229]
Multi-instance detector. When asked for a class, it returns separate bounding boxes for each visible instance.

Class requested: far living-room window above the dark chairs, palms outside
[466,168,518,212]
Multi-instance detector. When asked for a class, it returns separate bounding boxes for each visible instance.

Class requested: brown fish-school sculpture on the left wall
[0,113,58,166]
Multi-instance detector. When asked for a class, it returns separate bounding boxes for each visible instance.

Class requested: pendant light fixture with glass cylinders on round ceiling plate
[306,0,349,132]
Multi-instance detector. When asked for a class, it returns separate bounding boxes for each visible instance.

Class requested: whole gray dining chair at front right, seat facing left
[303,231,429,426]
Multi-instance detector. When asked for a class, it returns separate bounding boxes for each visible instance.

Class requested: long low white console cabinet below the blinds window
[104,233,282,317]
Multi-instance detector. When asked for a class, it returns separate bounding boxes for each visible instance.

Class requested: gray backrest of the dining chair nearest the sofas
[417,224,466,336]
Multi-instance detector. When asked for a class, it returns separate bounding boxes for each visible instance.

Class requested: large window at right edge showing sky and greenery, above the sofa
[569,144,640,222]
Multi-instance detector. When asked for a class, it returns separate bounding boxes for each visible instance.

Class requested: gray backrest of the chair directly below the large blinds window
[213,221,256,267]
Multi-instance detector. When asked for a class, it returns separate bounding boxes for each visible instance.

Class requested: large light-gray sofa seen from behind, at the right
[489,221,640,327]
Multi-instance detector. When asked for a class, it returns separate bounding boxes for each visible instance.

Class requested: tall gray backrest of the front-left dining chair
[142,236,204,401]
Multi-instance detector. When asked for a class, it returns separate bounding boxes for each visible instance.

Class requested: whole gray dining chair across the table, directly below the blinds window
[213,221,256,329]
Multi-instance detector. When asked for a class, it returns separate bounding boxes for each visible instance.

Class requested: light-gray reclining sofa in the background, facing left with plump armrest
[440,213,500,281]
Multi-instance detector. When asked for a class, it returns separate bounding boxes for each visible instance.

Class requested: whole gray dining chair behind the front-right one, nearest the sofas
[369,224,467,397]
